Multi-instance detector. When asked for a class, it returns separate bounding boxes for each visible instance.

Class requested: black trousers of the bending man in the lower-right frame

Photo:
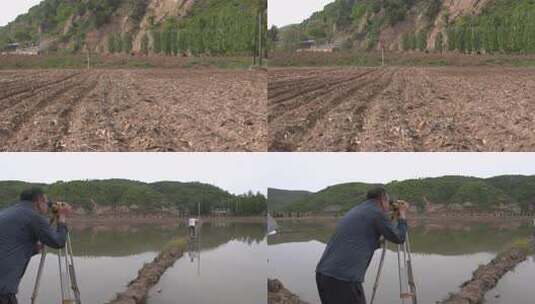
[316,272,366,304]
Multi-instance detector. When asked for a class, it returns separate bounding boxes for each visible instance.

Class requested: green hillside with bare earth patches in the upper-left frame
[0,0,267,55]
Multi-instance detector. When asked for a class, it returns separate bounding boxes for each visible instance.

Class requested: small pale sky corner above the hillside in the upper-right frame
[268,0,334,27]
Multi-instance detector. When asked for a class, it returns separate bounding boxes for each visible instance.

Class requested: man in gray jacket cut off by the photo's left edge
[0,188,71,304]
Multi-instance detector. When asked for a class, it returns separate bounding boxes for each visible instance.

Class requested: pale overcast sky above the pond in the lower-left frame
[0,153,267,194]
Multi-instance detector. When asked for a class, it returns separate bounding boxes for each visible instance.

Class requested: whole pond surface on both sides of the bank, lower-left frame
[18,222,267,304]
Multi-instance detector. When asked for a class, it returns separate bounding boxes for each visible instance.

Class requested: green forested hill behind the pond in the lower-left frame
[0,179,266,215]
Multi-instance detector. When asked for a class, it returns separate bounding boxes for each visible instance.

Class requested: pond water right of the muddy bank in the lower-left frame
[147,223,267,304]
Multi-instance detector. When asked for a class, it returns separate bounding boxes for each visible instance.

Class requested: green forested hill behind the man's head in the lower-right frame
[268,176,535,213]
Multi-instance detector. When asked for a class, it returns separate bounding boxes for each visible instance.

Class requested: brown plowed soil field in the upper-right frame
[268,67,535,151]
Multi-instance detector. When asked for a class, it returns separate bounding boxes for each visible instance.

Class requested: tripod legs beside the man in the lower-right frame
[370,232,418,304]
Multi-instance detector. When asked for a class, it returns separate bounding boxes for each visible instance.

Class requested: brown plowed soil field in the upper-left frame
[0,69,267,152]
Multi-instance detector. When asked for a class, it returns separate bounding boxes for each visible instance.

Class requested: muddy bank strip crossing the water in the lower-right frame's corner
[440,247,527,304]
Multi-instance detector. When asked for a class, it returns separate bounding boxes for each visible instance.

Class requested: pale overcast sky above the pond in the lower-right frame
[266,153,535,191]
